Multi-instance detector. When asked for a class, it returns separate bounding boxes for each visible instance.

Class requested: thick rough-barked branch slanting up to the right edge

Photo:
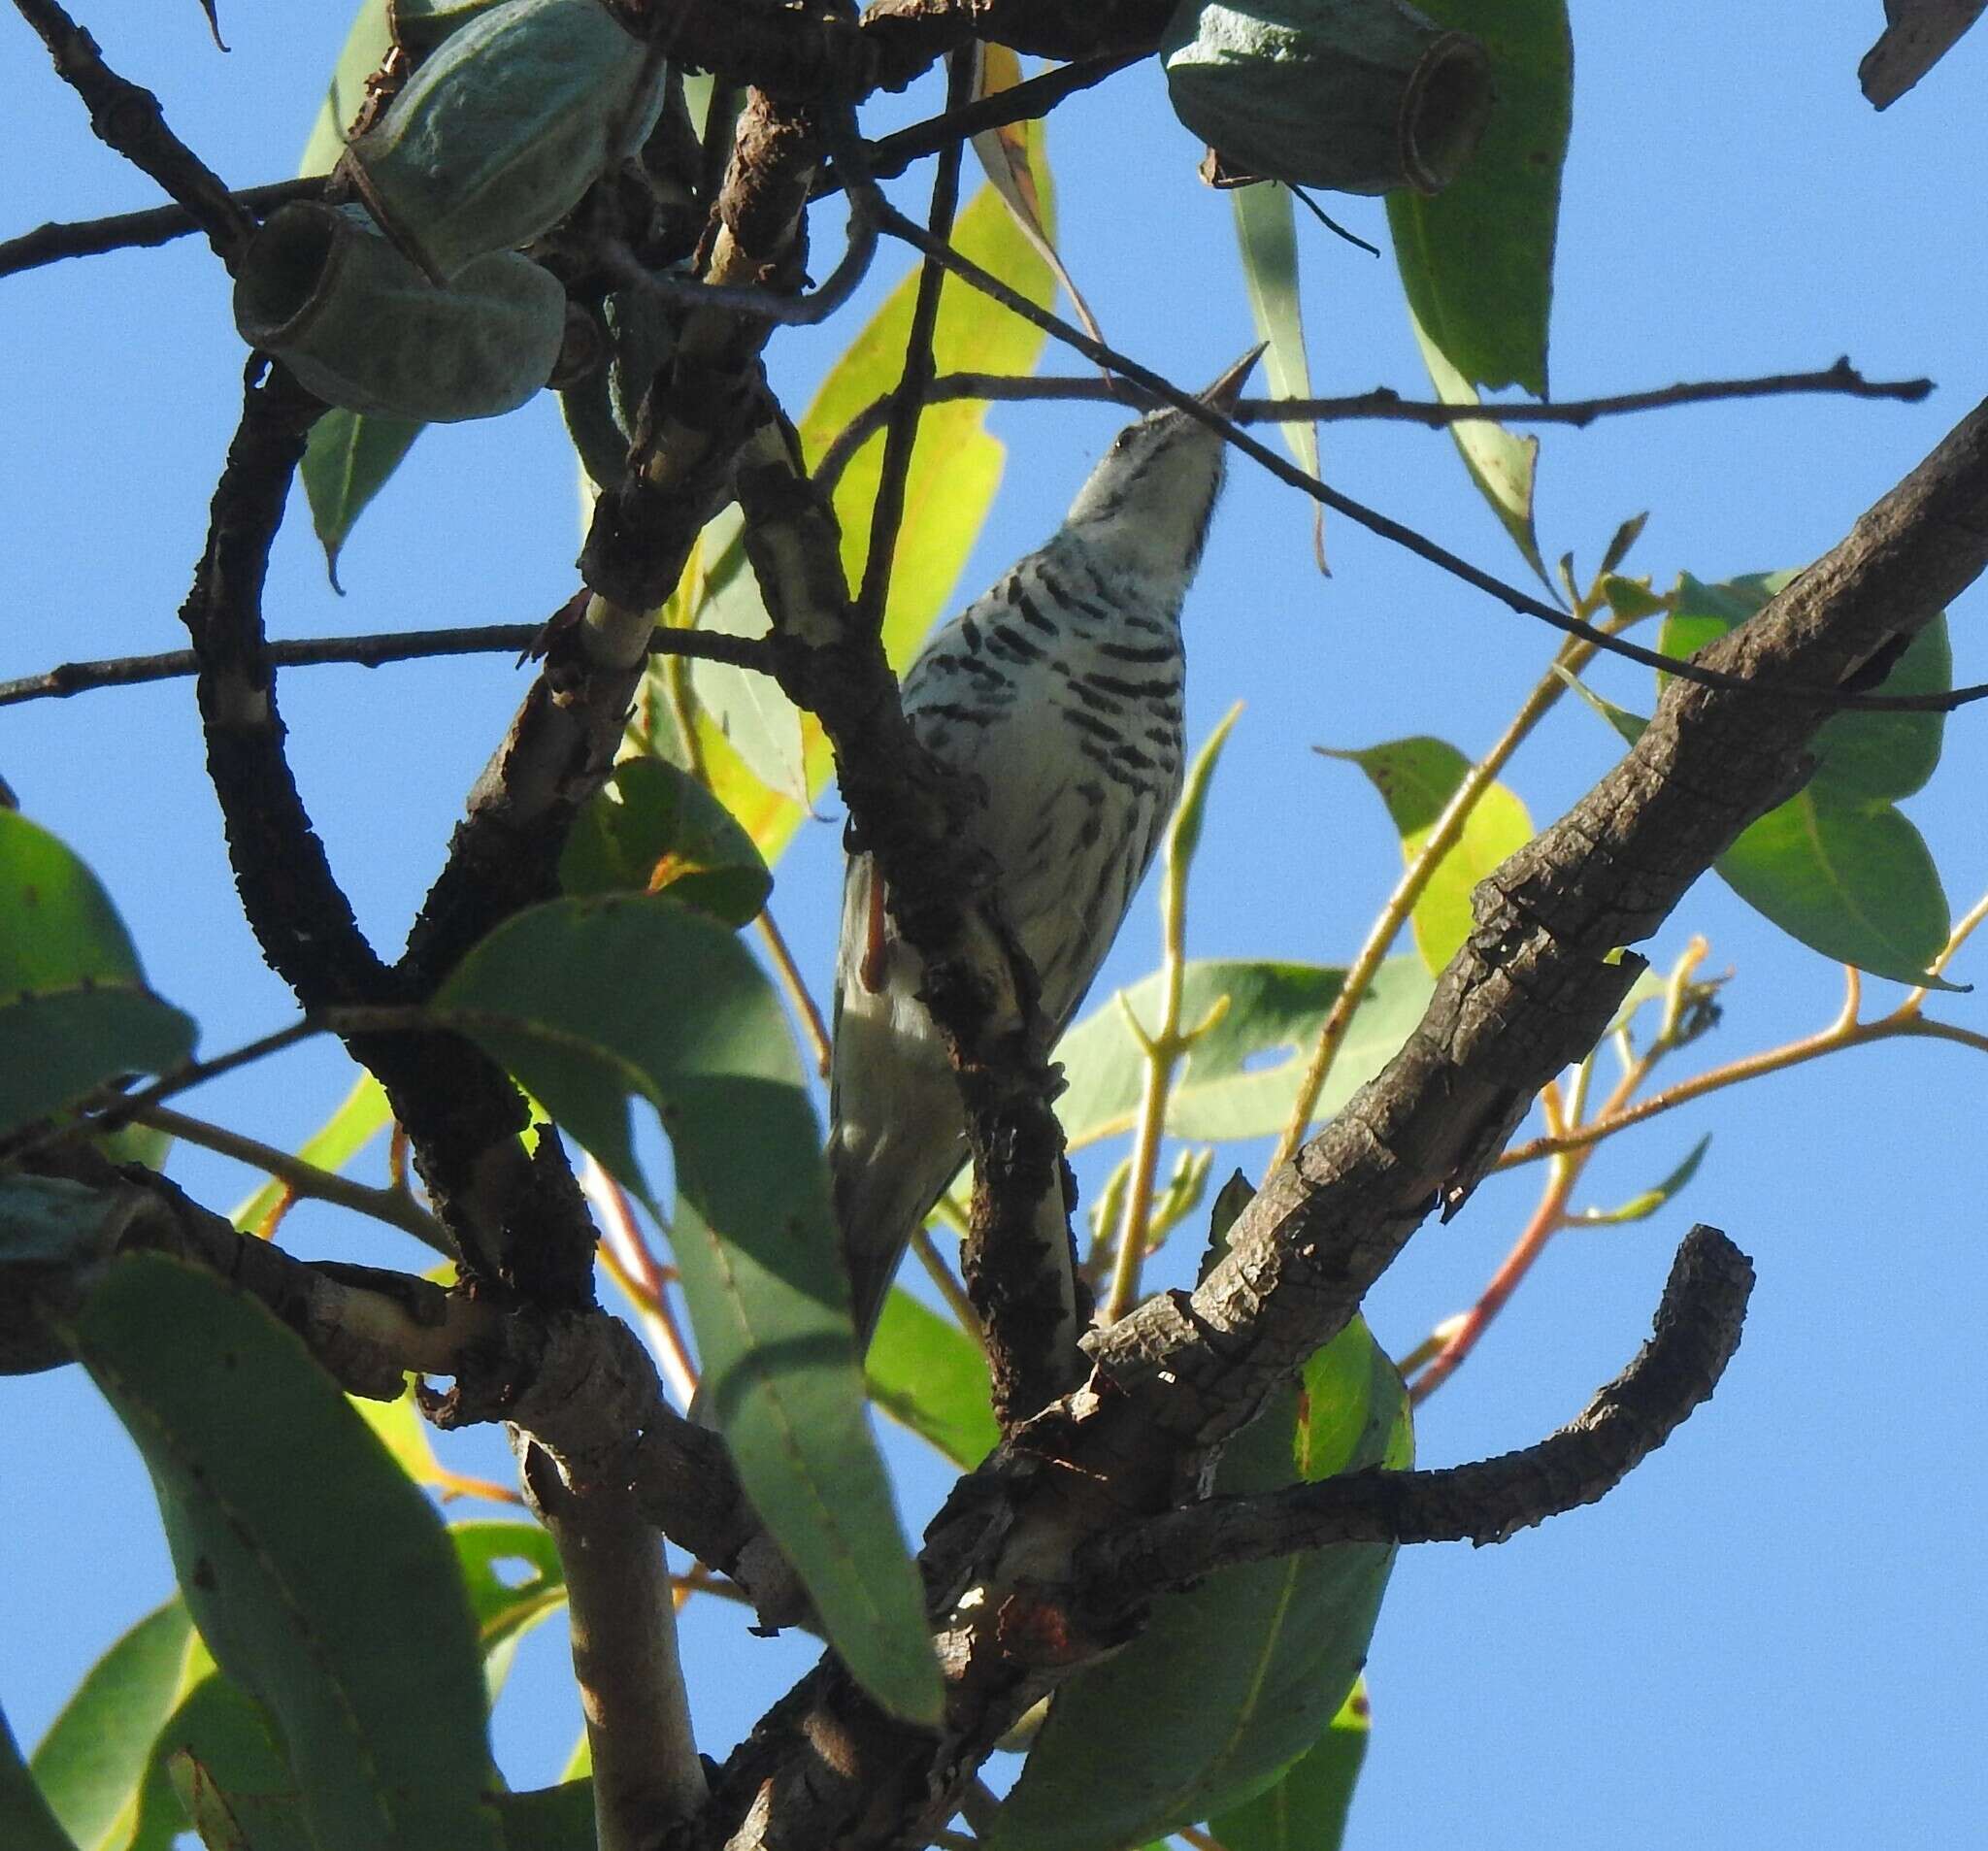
[1095,393,1988,1443]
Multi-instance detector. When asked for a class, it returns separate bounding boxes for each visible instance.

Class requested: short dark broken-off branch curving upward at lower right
[1079,1225,1753,1614]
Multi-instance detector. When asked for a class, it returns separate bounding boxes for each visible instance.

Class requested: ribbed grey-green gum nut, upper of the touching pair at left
[340,0,662,281]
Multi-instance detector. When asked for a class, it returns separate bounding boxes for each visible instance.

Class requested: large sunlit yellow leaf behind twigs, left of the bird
[676,139,1055,863]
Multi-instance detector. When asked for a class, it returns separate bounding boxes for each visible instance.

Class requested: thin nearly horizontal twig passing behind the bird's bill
[815,357,1933,487]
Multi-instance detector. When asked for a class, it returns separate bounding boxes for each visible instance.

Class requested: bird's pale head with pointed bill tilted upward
[1064,347,1262,586]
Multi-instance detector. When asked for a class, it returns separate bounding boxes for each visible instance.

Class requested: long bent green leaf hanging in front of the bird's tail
[433,897,941,1720]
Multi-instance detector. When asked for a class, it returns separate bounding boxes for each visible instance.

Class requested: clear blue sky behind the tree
[0,0,1988,1847]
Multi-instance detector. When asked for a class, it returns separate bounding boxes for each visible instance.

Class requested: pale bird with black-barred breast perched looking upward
[829,347,1262,1342]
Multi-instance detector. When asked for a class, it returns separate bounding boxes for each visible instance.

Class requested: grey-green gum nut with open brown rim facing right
[1159,0,1491,193]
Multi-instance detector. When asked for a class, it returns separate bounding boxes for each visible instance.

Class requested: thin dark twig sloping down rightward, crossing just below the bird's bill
[851,200,1988,713]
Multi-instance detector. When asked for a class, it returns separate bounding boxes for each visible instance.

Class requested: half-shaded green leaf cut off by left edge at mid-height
[0,810,195,1132]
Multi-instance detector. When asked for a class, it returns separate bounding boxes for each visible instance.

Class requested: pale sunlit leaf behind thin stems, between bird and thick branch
[1055,958,1432,1149]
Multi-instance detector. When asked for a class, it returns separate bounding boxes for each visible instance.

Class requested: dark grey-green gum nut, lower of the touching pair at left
[235,203,567,423]
